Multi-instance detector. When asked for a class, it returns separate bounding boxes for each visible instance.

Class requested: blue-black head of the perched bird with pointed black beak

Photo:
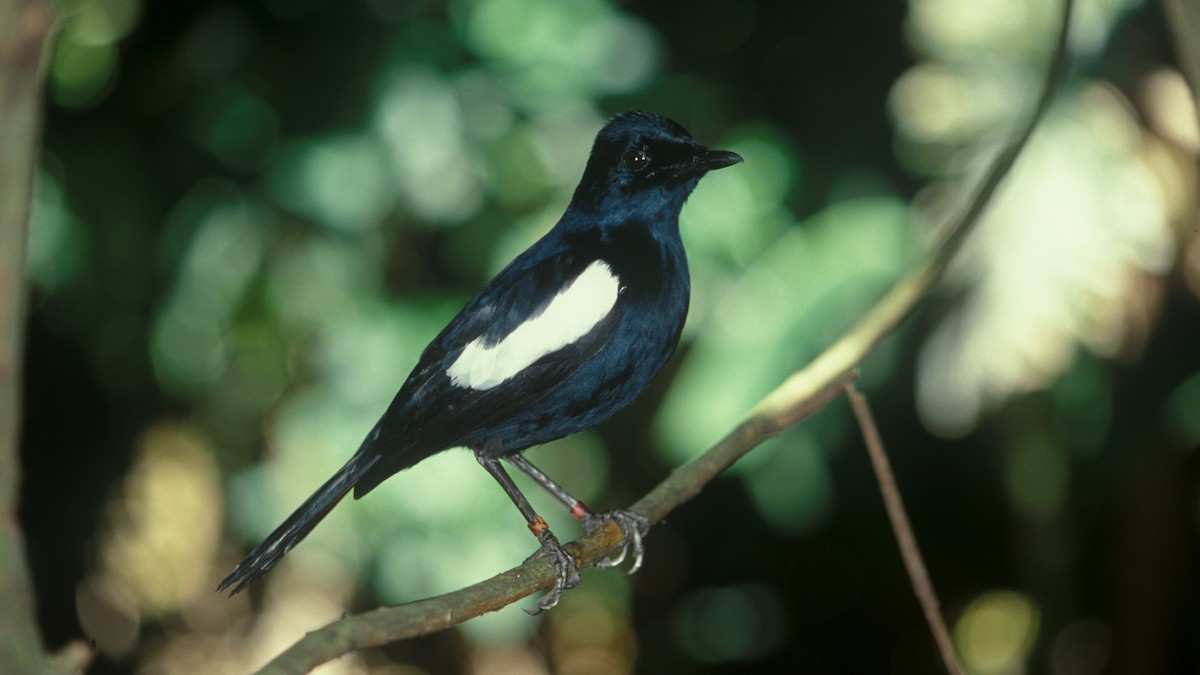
[571,110,742,216]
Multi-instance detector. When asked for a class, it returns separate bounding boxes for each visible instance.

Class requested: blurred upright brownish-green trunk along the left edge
[0,0,52,674]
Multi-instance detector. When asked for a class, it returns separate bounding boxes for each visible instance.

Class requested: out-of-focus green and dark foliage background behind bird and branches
[20,0,1200,675]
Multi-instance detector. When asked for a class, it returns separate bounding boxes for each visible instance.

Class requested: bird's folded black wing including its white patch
[355,239,622,496]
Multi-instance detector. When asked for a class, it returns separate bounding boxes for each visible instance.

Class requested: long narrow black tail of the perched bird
[217,448,379,596]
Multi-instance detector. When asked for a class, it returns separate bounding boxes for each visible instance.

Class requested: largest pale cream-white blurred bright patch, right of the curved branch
[917,86,1175,437]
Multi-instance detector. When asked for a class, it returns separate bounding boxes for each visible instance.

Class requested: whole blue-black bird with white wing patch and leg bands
[217,110,743,614]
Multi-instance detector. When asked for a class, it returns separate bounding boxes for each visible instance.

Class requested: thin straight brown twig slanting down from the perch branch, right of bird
[846,383,962,675]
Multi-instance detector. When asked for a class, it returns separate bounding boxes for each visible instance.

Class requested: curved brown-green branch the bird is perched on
[259,0,1073,674]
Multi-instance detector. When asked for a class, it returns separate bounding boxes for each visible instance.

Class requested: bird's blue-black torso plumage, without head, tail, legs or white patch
[355,221,690,496]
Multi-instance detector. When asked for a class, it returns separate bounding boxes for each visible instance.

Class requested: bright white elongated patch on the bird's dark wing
[446,261,620,390]
